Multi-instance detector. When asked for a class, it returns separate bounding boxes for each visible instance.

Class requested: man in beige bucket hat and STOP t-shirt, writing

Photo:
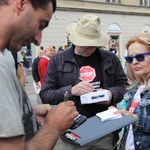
[40,14,127,150]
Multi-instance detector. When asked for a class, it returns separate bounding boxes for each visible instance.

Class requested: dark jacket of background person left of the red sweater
[32,57,40,82]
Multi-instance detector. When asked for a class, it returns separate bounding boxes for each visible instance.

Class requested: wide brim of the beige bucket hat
[67,25,110,46]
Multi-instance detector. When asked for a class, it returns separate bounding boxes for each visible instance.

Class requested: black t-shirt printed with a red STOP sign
[74,50,107,118]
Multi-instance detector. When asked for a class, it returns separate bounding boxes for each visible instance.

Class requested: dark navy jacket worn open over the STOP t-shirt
[40,47,127,105]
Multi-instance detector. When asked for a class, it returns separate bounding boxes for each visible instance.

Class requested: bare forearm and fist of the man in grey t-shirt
[0,101,79,150]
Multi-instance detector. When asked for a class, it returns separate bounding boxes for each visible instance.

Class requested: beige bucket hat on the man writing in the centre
[67,14,110,46]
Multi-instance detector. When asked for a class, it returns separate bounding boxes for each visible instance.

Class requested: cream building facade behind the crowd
[28,0,150,67]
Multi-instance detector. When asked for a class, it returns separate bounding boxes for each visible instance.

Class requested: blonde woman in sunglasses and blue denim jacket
[118,34,150,150]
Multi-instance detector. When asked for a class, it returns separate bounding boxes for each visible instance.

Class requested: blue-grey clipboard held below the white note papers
[63,115,138,146]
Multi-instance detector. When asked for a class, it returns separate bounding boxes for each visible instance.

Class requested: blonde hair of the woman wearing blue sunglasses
[126,34,150,90]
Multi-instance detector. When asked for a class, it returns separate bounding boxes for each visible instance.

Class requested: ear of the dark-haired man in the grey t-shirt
[15,0,29,15]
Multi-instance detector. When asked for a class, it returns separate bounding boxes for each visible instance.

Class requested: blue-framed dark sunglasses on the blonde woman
[124,52,150,64]
